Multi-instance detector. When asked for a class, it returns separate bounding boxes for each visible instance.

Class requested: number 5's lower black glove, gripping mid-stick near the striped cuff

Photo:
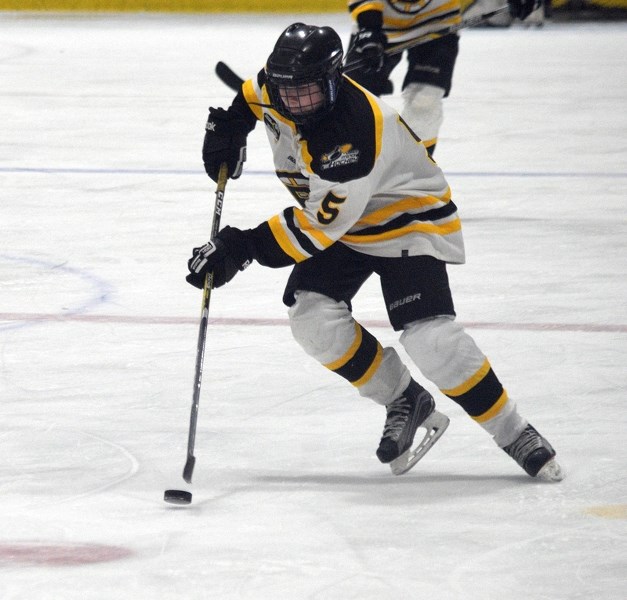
[185,225,252,289]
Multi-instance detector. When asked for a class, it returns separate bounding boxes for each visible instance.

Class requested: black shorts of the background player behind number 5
[347,34,459,97]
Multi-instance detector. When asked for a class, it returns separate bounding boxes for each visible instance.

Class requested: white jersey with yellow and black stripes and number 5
[242,72,464,263]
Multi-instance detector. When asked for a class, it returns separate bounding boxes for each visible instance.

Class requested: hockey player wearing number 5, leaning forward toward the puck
[187,23,561,480]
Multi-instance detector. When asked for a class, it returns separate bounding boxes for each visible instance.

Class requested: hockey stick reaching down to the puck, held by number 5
[183,163,228,483]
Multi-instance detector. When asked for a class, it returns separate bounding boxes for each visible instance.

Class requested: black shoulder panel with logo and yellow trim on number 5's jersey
[304,80,382,183]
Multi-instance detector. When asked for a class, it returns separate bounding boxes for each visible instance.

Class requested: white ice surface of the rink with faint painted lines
[0,13,627,600]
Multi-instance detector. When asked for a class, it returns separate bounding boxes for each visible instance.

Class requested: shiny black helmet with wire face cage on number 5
[266,23,344,125]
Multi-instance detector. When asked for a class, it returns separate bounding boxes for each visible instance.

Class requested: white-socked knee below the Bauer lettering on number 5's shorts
[401,317,485,389]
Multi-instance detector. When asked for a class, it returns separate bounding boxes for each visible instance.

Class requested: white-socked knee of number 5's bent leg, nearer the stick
[288,291,355,362]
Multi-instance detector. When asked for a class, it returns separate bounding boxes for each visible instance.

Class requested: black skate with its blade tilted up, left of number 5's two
[377,379,449,475]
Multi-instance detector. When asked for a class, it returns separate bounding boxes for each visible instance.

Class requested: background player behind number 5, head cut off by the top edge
[347,0,539,155]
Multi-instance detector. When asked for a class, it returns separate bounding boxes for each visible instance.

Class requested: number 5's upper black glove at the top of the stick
[202,107,250,181]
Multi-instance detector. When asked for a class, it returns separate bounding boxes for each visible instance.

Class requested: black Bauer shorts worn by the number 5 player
[283,242,455,331]
